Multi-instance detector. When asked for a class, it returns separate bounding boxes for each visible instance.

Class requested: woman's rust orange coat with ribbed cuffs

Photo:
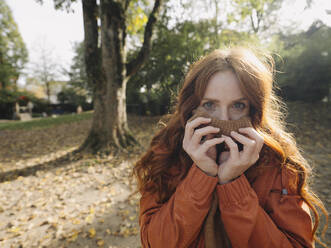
[139,164,314,248]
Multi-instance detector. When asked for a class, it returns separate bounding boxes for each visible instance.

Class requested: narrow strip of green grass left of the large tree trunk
[0,111,93,131]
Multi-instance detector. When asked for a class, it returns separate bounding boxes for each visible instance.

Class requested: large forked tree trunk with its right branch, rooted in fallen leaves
[80,0,161,153]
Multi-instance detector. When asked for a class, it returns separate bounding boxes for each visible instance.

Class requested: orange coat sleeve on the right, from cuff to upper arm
[217,169,314,248]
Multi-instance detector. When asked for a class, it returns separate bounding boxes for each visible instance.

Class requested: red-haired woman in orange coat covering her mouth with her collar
[134,48,327,248]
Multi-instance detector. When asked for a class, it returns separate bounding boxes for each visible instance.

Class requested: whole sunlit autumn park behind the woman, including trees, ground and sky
[0,0,331,247]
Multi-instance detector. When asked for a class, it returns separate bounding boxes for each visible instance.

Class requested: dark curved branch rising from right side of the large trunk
[126,0,163,77]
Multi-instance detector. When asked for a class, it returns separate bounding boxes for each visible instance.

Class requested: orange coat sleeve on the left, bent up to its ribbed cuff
[139,164,217,248]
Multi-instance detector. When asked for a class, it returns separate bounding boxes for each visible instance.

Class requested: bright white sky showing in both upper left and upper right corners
[5,0,331,84]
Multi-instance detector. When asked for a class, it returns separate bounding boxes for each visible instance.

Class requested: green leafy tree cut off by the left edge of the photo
[0,0,28,88]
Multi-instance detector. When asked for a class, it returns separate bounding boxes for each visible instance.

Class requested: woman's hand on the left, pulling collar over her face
[183,117,225,176]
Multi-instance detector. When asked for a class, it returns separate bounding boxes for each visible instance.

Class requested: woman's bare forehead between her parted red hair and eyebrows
[203,71,244,102]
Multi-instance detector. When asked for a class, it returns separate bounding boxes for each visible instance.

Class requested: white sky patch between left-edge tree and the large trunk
[5,0,84,84]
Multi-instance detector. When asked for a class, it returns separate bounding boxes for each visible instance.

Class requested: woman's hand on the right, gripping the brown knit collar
[218,127,264,184]
